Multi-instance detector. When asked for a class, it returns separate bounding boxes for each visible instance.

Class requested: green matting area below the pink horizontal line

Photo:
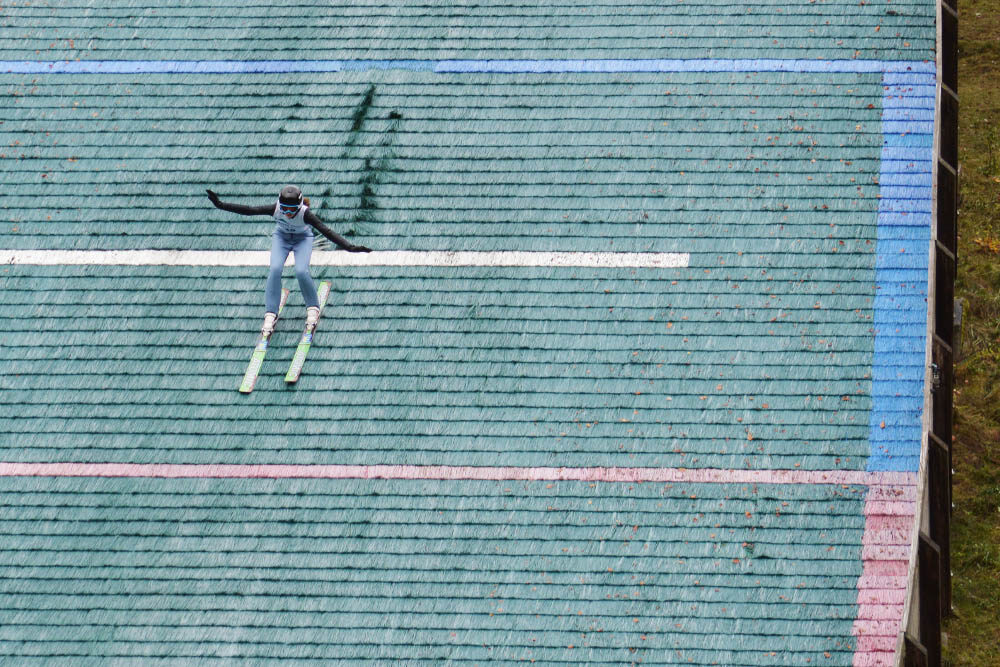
[0,478,864,666]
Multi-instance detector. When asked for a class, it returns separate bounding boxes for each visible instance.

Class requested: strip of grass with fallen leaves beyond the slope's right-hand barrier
[945,0,1000,667]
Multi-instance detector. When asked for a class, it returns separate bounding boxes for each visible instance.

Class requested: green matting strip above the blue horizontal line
[0,0,936,60]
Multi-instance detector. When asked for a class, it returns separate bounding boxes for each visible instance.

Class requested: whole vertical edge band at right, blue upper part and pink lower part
[852,71,935,667]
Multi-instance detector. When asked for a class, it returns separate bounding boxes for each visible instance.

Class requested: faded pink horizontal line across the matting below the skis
[0,463,916,486]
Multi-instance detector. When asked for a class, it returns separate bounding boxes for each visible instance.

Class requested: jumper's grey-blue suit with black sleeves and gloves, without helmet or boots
[209,191,371,313]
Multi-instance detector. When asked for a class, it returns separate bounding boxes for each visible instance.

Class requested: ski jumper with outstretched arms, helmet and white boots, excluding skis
[206,185,371,336]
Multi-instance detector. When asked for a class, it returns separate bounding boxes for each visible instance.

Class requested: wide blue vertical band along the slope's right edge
[866,71,935,472]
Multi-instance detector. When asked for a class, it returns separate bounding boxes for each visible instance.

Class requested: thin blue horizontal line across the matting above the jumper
[0,59,934,74]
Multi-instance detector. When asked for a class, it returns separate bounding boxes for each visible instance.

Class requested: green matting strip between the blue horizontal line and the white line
[0,71,883,253]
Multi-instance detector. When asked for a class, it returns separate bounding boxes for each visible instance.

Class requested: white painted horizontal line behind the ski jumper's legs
[0,250,691,269]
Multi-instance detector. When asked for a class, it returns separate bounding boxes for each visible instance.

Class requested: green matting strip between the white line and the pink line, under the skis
[0,266,916,470]
